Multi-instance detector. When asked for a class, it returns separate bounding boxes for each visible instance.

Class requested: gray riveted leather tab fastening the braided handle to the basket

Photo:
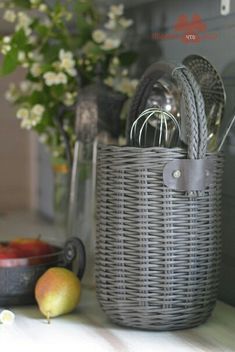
[163,159,214,192]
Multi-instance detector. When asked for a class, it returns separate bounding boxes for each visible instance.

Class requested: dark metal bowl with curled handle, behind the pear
[0,238,86,307]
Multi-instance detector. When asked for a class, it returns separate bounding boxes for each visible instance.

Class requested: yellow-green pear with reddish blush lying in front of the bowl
[35,267,81,323]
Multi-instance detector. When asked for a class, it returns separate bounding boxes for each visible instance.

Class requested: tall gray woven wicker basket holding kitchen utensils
[96,64,223,330]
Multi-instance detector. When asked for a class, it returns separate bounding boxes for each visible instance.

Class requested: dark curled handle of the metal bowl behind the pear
[63,237,86,279]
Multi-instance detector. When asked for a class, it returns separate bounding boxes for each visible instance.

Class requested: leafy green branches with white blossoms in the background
[0,0,137,164]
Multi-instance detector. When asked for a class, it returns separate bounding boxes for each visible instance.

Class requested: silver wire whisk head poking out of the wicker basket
[130,108,181,148]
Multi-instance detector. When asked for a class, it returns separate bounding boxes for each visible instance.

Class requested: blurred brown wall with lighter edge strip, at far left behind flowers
[0,9,39,213]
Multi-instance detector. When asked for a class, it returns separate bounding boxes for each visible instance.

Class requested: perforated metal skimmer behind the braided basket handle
[183,55,226,151]
